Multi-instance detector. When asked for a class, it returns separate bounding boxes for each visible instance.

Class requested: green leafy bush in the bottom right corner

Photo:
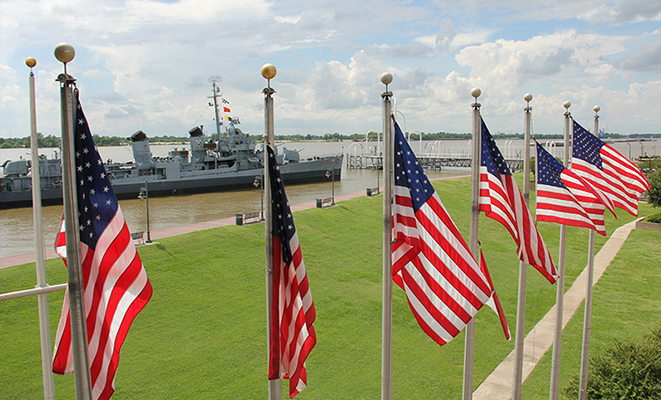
[565,327,661,400]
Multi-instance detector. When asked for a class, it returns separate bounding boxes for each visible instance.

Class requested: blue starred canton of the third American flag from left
[394,123,434,212]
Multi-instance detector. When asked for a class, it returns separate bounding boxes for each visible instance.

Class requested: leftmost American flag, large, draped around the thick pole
[53,93,152,399]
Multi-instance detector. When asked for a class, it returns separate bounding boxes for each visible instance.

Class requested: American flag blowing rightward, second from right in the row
[535,141,614,236]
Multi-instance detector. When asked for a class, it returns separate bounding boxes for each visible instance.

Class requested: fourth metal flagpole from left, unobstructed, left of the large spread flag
[381,72,394,400]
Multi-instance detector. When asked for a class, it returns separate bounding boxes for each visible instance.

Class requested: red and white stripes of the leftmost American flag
[53,209,152,399]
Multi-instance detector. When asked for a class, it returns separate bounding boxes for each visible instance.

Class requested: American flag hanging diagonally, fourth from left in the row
[480,120,557,283]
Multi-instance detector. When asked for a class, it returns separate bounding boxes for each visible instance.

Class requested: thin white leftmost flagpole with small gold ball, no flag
[25,57,55,400]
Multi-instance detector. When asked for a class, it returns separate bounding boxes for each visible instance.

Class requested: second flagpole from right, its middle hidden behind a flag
[549,101,571,400]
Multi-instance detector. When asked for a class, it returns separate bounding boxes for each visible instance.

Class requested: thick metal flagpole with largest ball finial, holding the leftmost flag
[55,43,92,400]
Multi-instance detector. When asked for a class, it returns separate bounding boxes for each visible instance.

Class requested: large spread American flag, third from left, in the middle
[392,124,492,345]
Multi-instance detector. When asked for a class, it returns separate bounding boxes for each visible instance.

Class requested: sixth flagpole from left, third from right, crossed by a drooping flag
[512,93,532,400]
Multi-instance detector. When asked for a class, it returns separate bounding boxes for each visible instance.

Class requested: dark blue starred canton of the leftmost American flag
[74,91,117,250]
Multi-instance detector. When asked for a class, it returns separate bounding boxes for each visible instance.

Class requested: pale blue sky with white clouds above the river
[0,0,661,138]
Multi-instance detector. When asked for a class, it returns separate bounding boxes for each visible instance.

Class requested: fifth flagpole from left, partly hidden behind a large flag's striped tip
[462,88,482,400]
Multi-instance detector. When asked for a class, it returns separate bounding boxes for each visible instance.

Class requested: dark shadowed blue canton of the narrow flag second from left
[266,146,296,265]
